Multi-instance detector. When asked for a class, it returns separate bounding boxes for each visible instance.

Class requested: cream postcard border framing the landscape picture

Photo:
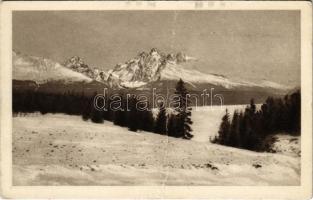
[0,1,312,199]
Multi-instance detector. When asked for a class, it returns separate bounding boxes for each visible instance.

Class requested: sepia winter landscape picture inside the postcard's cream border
[1,2,312,198]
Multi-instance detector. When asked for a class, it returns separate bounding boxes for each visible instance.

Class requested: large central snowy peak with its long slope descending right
[103,48,287,90]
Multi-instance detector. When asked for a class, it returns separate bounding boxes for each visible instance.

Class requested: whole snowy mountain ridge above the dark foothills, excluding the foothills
[13,48,290,91]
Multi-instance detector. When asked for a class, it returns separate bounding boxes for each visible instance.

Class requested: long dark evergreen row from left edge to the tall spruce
[13,80,193,139]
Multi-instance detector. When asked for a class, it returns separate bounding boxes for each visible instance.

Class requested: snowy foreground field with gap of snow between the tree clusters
[13,106,300,185]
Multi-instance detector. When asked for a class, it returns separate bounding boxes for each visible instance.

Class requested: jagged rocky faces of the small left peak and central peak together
[64,48,187,88]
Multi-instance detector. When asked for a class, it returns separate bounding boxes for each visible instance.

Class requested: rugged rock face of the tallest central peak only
[107,48,186,87]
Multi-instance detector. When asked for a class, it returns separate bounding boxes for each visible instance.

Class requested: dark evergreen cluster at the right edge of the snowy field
[213,91,301,151]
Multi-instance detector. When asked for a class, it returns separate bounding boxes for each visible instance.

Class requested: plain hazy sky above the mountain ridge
[13,11,300,86]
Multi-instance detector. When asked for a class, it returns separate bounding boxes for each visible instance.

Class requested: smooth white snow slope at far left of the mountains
[12,51,92,83]
